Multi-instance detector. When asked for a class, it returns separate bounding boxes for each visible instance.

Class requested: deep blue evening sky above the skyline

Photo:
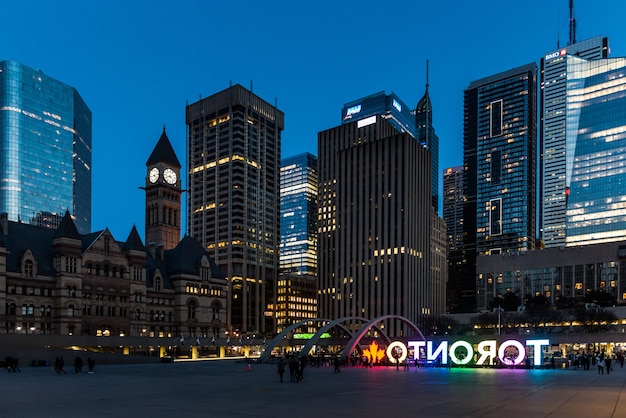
[0,0,626,240]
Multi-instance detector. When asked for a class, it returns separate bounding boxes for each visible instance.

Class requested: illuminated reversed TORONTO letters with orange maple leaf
[363,339,550,366]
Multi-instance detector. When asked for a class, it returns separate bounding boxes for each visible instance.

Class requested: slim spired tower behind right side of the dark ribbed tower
[415,70,439,212]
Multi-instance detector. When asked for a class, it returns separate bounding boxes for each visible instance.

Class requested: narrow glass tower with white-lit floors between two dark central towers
[280,153,318,276]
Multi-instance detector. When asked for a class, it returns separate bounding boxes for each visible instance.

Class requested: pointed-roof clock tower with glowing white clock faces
[145,128,182,250]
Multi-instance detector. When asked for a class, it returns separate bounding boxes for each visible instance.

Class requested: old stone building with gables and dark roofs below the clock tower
[0,213,227,339]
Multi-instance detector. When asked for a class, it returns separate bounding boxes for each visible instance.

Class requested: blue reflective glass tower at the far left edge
[0,61,91,233]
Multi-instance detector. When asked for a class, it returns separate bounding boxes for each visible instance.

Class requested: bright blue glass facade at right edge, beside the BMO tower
[566,56,626,246]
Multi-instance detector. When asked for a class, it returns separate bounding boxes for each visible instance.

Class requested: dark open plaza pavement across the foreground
[0,359,626,418]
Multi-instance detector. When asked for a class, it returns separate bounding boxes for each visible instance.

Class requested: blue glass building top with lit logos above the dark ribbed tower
[341,91,415,137]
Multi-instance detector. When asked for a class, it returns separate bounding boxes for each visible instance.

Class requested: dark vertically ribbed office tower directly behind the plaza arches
[318,115,434,335]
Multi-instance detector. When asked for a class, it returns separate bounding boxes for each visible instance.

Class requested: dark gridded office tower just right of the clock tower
[186,85,284,333]
